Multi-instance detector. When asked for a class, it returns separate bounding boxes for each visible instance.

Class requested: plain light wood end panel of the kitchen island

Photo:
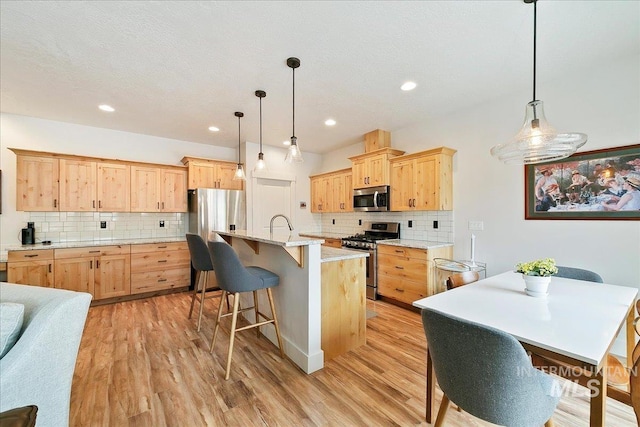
[321,258,367,362]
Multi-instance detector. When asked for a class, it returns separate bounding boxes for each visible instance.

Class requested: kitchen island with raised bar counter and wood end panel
[215,231,368,373]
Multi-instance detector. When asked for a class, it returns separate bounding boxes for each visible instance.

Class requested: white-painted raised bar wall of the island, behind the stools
[233,241,324,374]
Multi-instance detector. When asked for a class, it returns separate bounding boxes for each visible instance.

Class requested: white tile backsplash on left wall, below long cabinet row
[29,212,188,242]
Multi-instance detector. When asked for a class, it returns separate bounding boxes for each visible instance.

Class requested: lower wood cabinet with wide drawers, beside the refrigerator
[131,242,191,294]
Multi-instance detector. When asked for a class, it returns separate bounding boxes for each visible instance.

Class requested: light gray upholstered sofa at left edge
[0,283,91,427]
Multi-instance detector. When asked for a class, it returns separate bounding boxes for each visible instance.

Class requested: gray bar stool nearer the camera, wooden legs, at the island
[209,242,284,380]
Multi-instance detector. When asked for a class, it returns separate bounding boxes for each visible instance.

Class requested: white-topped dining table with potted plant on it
[413,272,638,426]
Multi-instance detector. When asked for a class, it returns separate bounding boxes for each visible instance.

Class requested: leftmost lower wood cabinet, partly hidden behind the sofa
[7,249,54,288]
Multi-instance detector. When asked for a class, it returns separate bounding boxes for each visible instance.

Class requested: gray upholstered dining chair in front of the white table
[422,308,561,427]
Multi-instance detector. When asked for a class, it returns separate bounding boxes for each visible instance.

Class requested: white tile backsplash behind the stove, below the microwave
[321,211,454,243]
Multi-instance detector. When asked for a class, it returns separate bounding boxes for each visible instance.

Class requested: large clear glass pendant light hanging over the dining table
[491,0,587,165]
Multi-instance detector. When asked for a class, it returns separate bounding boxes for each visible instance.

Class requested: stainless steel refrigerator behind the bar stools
[189,188,247,241]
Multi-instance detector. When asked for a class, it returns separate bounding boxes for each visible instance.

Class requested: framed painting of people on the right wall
[524,144,640,221]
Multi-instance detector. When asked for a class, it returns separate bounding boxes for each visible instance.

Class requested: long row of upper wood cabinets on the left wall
[11,148,188,212]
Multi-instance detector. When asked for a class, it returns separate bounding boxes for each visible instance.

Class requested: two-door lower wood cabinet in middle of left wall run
[54,245,131,300]
